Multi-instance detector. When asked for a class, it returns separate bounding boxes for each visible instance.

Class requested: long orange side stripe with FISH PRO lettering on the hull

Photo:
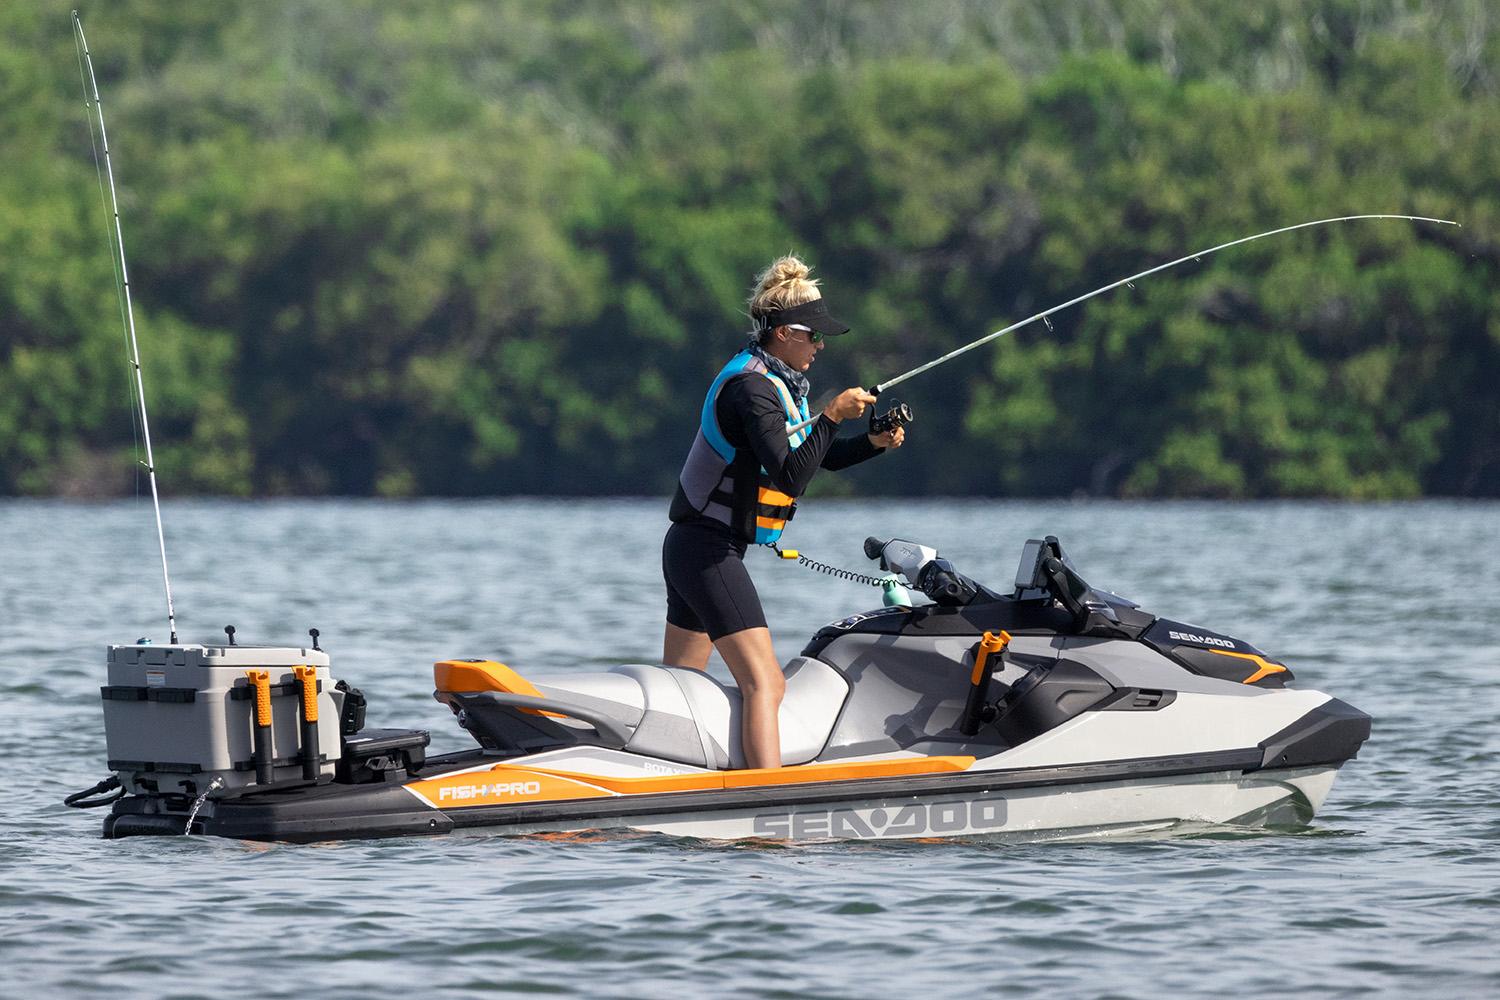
[426,757,974,808]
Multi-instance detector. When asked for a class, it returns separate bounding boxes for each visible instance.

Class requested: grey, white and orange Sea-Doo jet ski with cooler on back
[82,537,1370,841]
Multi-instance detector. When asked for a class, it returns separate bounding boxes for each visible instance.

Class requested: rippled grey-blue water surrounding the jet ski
[0,499,1500,999]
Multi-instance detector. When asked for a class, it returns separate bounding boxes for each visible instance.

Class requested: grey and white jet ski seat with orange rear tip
[434,657,849,769]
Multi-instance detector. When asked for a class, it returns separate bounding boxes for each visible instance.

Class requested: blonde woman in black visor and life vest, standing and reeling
[662,256,906,768]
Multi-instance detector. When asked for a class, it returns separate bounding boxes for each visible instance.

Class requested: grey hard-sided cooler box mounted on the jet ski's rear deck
[101,645,344,796]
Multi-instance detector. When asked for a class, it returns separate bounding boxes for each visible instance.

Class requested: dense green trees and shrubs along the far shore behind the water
[0,0,1500,499]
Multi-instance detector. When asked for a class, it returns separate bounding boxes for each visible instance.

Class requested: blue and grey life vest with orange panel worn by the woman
[678,349,812,544]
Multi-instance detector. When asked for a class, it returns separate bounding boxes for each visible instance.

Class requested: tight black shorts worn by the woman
[662,520,765,640]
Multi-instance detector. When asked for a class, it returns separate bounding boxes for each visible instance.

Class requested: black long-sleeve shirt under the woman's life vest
[671,372,885,541]
